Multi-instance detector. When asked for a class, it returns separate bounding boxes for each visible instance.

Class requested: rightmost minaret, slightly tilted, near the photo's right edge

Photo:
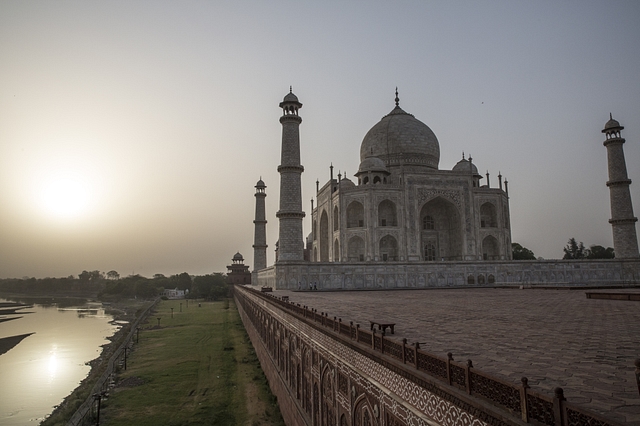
[602,114,639,259]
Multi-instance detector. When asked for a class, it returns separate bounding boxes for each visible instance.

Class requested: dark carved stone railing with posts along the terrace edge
[235,287,624,426]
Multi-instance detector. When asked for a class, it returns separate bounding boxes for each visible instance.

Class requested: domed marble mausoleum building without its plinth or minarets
[311,90,511,262]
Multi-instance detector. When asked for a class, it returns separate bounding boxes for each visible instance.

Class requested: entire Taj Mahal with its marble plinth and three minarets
[252,89,640,290]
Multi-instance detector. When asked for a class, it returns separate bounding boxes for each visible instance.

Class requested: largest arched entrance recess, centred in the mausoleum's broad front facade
[418,197,462,261]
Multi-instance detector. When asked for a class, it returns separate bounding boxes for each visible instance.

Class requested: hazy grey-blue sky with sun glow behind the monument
[0,0,640,278]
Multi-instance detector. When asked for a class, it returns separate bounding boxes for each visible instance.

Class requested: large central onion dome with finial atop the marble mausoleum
[360,100,440,169]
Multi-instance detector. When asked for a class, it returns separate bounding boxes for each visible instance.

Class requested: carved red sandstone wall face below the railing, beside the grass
[236,290,500,426]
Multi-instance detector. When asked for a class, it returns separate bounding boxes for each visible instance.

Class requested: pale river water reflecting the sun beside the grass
[0,299,119,426]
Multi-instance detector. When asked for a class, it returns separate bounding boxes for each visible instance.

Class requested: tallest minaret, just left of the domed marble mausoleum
[276,88,304,263]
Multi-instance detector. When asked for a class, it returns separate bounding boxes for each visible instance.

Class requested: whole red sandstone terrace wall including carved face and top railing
[235,287,618,426]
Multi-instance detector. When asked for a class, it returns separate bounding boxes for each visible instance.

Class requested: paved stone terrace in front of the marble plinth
[260,288,640,426]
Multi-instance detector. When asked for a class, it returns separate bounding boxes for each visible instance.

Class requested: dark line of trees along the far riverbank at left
[0,271,229,300]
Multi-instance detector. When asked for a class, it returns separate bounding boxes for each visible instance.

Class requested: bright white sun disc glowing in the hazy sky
[40,175,91,219]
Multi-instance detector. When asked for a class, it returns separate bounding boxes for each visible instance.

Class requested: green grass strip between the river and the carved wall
[100,300,284,426]
